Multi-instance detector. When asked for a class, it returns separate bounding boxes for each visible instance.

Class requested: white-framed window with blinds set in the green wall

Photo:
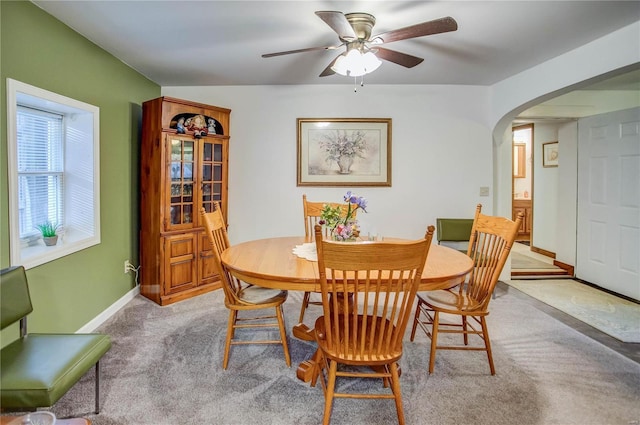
[7,79,100,268]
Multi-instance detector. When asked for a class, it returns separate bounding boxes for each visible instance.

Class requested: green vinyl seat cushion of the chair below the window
[0,334,111,409]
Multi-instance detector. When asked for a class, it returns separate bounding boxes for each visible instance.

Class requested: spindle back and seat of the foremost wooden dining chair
[315,225,434,363]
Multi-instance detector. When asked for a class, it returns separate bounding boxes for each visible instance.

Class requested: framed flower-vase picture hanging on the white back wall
[297,118,391,186]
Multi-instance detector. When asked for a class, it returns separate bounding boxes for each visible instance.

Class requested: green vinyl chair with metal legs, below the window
[0,266,111,413]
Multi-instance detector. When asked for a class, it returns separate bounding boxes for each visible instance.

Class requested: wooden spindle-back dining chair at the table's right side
[411,204,522,375]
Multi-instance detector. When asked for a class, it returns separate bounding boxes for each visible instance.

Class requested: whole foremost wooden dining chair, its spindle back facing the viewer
[308,225,435,425]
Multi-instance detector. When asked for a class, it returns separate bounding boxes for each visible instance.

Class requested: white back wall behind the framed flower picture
[162,85,493,243]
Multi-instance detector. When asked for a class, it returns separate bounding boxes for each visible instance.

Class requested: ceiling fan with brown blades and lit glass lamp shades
[262,11,458,77]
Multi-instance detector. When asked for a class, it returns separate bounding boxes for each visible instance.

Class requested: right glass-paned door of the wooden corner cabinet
[200,140,223,212]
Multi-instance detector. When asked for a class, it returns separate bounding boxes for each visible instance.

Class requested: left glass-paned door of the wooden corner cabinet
[167,137,197,229]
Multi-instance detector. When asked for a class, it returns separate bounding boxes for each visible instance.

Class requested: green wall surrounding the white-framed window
[0,1,160,346]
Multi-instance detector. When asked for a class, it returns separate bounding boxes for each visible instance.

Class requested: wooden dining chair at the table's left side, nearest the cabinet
[200,202,291,369]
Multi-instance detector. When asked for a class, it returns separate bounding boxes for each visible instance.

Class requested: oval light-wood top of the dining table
[221,236,473,292]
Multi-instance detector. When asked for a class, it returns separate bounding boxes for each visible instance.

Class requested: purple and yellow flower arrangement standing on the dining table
[318,191,367,241]
